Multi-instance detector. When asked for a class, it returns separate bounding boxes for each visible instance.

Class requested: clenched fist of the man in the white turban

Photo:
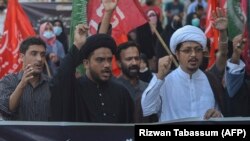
[156,55,173,80]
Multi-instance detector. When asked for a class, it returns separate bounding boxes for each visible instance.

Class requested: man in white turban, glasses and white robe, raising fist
[141,25,225,121]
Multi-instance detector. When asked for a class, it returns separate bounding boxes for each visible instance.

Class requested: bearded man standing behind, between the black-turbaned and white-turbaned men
[116,41,157,122]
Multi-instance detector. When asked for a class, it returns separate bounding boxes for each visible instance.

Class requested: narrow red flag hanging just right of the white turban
[205,0,219,68]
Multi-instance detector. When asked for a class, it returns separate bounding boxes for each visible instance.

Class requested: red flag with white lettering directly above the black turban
[87,0,147,76]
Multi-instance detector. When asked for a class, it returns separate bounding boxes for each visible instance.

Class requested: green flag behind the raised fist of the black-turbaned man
[70,0,88,75]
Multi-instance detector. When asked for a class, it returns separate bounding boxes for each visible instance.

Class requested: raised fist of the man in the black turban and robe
[74,24,89,50]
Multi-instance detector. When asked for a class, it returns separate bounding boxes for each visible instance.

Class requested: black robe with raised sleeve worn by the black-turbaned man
[51,46,134,123]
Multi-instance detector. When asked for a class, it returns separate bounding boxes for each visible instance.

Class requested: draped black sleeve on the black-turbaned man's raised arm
[50,46,80,121]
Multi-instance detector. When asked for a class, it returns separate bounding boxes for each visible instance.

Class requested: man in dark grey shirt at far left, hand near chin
[0,37,51,121]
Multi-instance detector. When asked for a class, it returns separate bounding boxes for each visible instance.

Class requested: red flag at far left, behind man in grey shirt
[0,0,35,78]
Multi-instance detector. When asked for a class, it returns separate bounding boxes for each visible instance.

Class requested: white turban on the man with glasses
[170,25,207,54]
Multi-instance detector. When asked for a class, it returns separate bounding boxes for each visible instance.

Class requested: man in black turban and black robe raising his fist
[52,25,134,123]
